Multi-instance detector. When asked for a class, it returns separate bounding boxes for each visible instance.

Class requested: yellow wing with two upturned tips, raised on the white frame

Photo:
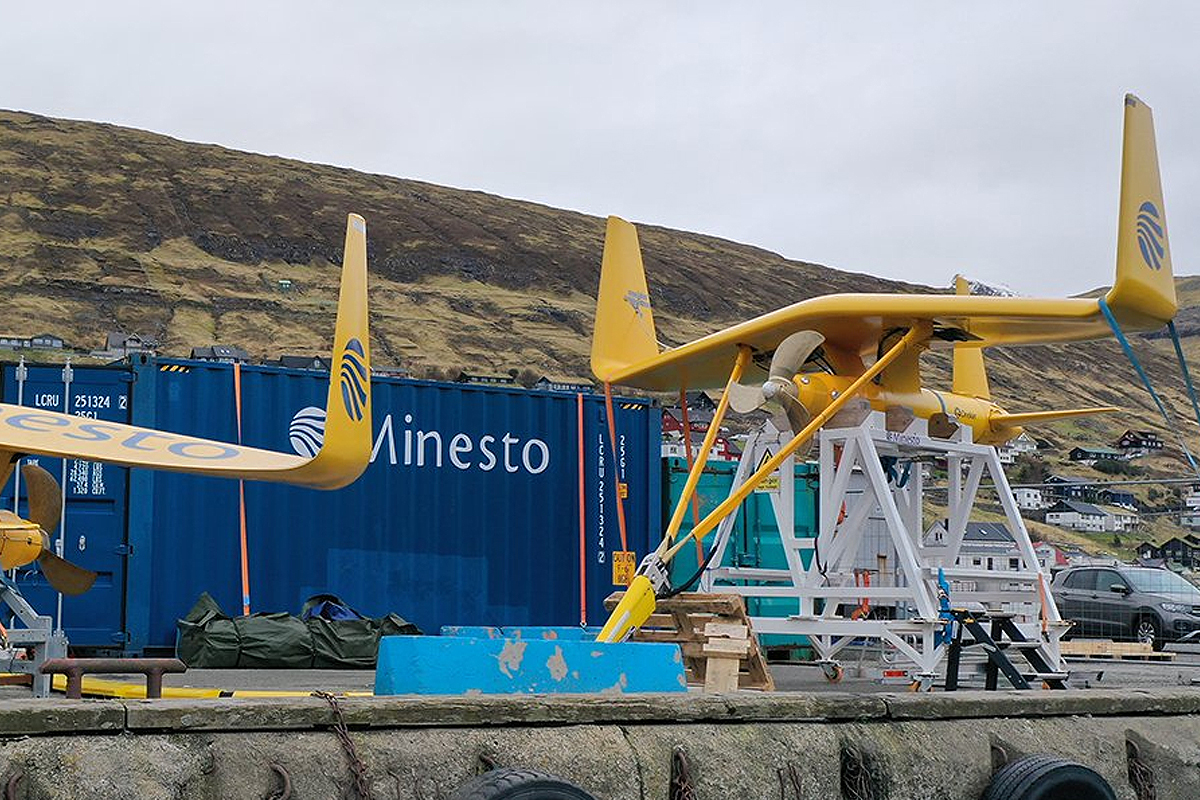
[592,95,1176,391]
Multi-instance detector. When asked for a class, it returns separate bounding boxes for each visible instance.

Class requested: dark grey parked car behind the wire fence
[1051,565,1200,650]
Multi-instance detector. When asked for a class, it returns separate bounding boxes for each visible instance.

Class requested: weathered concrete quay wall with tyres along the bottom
[0,688,1200,800]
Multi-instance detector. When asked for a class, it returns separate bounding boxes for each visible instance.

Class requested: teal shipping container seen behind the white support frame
[662,457,818,648]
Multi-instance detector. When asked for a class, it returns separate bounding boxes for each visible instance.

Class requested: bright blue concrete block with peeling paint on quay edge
[374,636,688,694]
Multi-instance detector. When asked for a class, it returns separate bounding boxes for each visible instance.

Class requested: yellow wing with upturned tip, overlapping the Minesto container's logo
[0,213,371,489]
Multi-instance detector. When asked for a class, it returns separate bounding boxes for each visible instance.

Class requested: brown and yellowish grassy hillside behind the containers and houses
[0,106,1200,551]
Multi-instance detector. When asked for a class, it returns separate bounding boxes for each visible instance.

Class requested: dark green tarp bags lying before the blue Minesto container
[178,593,420,669]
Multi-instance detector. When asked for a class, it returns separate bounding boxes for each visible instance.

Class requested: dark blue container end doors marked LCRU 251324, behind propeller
[0,365,130,648]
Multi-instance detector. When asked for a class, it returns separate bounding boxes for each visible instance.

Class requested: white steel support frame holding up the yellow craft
[701,411,1069,684]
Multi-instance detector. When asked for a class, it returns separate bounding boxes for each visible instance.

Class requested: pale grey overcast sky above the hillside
[0,0,1200,301]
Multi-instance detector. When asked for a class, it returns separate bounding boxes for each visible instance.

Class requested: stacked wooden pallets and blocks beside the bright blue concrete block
[604,591,775,692]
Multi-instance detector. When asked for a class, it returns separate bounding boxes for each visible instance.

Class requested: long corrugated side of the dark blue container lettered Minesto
[130,361,661,646]
